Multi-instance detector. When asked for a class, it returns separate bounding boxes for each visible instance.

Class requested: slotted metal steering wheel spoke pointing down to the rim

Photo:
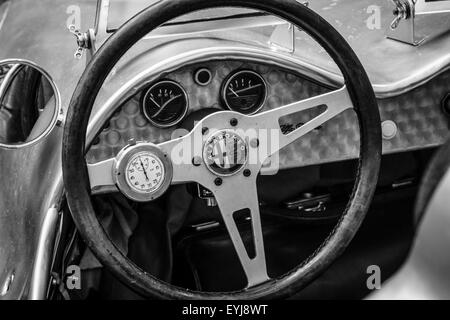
[212,175,270,287]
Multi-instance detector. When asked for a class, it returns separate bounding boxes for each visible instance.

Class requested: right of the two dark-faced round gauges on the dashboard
[222,70,267,114]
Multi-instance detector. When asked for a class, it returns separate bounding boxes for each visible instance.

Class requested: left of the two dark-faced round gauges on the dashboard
[142,80,189,128]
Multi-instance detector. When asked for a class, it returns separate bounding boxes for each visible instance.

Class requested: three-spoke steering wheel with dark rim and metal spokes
[62,0,381,299]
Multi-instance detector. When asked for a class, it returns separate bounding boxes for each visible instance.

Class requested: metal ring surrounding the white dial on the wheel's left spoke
[113,143,173,202]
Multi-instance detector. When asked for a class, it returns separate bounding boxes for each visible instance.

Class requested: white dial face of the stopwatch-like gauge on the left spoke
[125,151,164,193]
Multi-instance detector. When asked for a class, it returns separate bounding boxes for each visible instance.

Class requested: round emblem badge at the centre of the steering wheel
[203,130,249,176]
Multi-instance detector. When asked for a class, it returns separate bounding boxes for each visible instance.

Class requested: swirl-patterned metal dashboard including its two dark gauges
[86,59,450,169]
